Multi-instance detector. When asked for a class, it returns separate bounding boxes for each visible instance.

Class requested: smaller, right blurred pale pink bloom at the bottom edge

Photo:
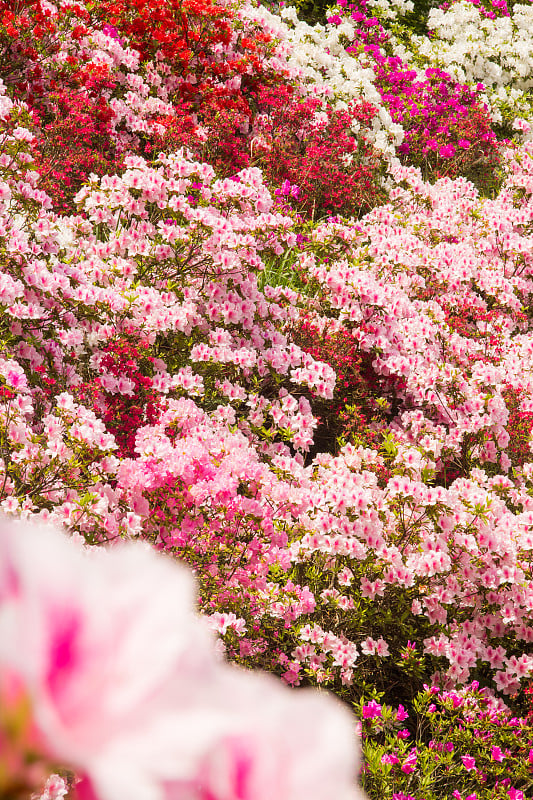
[172,670,363,800]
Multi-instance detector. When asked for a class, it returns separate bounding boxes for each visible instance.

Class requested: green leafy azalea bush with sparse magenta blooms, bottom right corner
[358,682,533,800]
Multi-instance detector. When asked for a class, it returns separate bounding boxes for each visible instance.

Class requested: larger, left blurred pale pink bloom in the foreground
[0,522,225,800]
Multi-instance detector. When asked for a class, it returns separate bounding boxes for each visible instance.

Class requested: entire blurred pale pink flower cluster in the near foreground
[0,520,366,800]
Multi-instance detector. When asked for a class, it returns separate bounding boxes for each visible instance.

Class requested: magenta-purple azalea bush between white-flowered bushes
[328,2,499,194]
